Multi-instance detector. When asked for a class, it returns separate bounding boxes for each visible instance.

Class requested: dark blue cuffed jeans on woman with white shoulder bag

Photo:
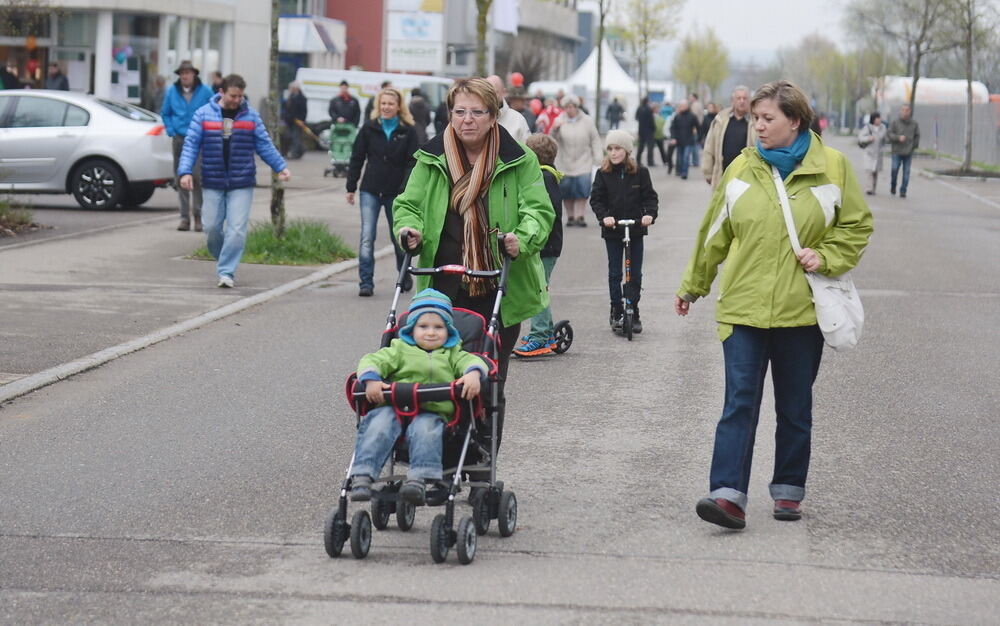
[709,326,823,509]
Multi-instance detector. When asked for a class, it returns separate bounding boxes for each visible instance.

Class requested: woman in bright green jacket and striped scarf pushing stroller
[393,78,555,449]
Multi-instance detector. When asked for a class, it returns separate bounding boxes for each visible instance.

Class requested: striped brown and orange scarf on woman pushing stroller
[444,124,500,296]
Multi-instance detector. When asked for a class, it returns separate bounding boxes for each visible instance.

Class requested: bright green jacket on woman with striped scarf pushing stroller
[392,128,555,326]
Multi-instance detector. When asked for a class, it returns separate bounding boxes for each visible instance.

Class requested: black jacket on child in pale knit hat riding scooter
[590,163,659,239]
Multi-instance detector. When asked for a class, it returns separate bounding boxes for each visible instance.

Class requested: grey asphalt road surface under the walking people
[0,141,1000,624]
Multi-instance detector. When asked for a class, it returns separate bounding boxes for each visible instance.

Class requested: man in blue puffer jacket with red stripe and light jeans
[177,74,291,287]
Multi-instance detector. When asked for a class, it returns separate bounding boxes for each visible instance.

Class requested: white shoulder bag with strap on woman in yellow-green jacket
[771,165,865,350]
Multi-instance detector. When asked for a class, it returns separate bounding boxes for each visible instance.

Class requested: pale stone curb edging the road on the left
[0,245,393,407]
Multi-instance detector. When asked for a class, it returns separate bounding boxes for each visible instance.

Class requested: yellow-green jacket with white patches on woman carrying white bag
[677,133,873,339]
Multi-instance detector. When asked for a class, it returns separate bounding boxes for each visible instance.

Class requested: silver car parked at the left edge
[0,89,174,209]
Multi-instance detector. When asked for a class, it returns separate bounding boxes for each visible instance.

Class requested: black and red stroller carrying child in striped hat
[323,235,517,565]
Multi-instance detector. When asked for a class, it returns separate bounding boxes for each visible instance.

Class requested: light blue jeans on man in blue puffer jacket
[201,187,253,278]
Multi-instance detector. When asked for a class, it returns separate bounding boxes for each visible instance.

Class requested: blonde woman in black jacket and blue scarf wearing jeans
[347,87,419,297]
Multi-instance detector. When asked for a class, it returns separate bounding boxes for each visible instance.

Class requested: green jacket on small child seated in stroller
[358,339,489,422]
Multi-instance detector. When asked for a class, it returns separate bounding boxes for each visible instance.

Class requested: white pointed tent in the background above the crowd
[529,41,639,127]
